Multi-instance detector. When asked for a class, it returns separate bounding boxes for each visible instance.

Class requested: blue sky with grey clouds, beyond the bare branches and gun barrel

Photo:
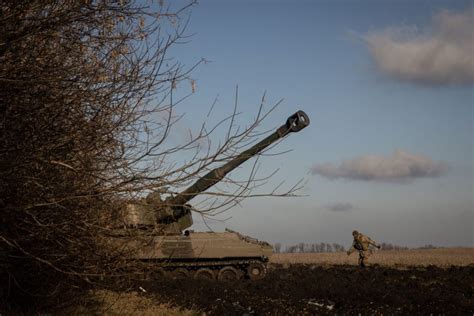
[162,0,474,247]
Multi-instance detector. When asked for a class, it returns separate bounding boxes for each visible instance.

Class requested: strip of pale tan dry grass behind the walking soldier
[270,248,474,267]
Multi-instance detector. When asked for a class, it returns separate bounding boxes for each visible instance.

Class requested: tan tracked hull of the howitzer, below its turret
[108,230,272,280]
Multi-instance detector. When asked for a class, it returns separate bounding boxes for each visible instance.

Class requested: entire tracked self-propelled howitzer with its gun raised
[115,111,309,279]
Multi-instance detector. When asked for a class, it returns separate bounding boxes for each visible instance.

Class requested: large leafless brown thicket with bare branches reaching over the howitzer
[0,0,304,312]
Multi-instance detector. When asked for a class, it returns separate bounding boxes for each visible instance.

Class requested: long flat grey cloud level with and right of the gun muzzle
[311,150,447,182]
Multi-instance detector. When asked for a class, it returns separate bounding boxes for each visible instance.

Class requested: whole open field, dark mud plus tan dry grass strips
[83,248,474,316]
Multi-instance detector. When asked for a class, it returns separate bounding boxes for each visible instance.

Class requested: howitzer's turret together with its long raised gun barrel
[120,111,309,234]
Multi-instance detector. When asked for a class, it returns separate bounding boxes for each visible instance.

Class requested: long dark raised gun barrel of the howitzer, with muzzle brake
[168,111,309,205]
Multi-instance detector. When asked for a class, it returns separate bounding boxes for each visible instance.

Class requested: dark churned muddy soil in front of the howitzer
[136,265,474,315]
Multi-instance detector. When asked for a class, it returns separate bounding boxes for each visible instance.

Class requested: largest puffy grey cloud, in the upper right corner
[364,8,474,84]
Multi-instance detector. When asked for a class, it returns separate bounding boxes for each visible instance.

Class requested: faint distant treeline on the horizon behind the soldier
[273,242,439,253]
